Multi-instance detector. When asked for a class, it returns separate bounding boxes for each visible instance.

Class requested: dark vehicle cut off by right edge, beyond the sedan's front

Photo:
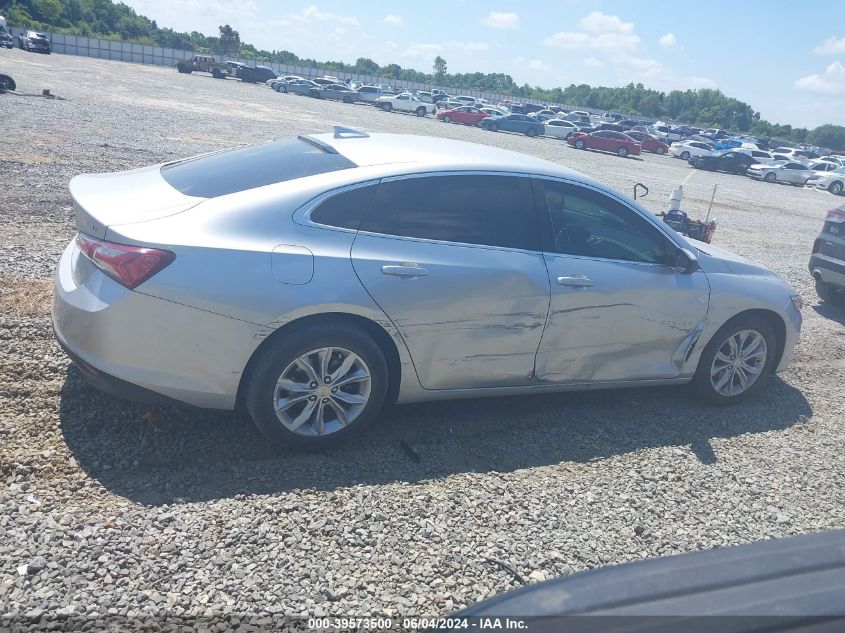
[809,205,845,306]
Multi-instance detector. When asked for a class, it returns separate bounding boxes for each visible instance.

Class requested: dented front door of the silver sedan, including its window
[533,178,710,383]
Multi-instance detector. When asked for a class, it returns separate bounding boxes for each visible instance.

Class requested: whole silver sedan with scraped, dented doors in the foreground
[53,128,801,447]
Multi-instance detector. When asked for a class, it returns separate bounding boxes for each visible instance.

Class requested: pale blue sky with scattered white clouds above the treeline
[123,0,845,127]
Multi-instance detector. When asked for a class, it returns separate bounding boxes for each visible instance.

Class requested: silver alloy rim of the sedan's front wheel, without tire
[710,330,769,397]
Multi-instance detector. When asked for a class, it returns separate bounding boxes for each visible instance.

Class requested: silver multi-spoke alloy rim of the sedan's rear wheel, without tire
[273,347,371,437]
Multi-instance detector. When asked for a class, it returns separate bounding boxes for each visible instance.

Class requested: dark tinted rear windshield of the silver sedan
[161,139,357,198]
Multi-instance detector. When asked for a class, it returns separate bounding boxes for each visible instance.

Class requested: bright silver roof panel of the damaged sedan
[311,134,592,182]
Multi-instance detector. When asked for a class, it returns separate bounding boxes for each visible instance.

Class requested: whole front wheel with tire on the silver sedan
[693,316,777,405]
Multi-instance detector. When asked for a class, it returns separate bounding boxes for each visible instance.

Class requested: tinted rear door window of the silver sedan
[361,175,539,250]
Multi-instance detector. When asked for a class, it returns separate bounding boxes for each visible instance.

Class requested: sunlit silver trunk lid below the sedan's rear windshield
[70,165,206,239]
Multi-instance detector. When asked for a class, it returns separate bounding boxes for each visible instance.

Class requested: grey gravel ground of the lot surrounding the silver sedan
[0,50,845,626]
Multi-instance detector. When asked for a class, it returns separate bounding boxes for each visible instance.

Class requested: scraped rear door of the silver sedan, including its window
[352,174,550,389]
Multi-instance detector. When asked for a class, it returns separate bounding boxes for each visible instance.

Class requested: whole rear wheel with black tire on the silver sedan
[245,324,388,449]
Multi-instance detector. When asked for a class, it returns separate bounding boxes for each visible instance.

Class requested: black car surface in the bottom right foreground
[451,530,845,633]
